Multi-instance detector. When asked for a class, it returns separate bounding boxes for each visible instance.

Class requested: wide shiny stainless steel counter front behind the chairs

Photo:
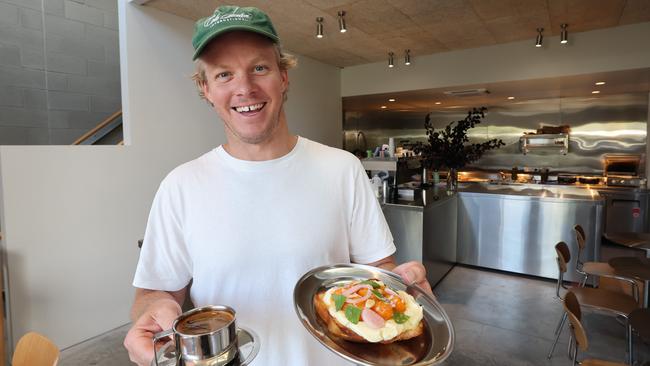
[458,184,604,281]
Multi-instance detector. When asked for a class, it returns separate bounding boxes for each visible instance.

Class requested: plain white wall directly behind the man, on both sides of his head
[0,0,341,348]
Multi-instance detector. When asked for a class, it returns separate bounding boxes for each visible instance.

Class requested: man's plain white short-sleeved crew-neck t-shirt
[133,137,395,366]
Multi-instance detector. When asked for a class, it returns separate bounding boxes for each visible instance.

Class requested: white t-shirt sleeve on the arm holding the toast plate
[350,160,395,264]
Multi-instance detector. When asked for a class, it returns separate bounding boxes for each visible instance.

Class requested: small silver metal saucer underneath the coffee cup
[151,327,260,366]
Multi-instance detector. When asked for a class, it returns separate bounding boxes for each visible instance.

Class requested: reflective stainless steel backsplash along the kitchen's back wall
[343,93,648,175]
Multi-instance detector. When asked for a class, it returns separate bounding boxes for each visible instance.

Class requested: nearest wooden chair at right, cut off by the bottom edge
[564,290,625,366]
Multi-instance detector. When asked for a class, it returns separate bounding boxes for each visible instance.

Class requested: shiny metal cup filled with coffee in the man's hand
[153,305,238,366]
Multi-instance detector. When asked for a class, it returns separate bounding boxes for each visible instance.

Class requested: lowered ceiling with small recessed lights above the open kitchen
[343,68,650,112]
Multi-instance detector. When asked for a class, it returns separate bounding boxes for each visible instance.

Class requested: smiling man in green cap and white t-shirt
[124,6,430,366]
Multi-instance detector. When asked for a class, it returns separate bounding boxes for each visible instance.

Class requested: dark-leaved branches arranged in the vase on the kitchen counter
[414,107,505,170]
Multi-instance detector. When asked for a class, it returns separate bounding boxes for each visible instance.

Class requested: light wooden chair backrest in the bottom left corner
[11,332,59,366]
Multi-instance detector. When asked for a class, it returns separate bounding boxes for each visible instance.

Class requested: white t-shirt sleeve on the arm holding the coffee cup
[133,176,192,291]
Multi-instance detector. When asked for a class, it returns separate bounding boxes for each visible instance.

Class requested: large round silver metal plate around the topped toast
[293,264,454,366]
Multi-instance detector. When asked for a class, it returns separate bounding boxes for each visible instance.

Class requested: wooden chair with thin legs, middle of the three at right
[548,241,639,358]
